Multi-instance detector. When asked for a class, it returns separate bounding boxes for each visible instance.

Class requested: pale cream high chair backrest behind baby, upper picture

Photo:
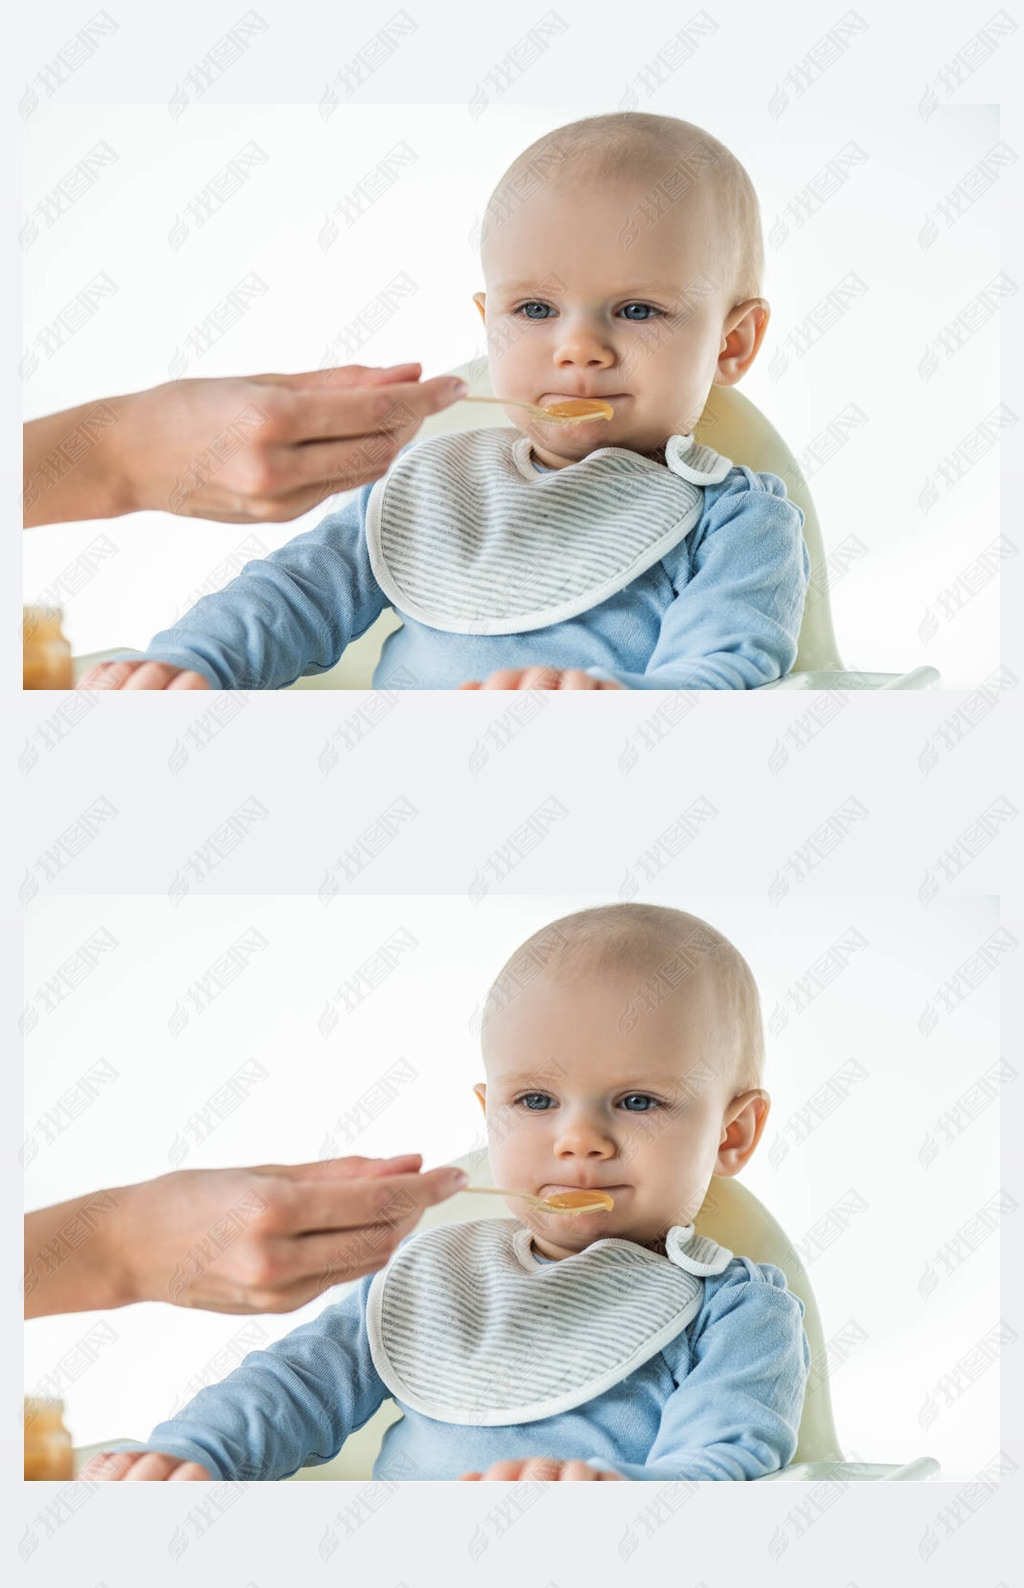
[418,359,843,672]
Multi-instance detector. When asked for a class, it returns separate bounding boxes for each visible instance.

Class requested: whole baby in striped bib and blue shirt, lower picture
[84,904,810,1480]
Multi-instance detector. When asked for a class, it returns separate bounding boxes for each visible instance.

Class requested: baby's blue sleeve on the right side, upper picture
[587,468,810,689]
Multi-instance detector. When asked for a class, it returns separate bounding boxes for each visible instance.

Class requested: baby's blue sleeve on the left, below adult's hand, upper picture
[134,483,389,689]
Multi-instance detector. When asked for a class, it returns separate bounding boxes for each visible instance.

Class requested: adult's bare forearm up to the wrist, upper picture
[24,397,137,529]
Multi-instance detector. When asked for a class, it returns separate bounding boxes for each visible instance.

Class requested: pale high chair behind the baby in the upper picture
[67,371,938,689]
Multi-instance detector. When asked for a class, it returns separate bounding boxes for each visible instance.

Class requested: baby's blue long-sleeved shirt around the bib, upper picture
[138,443,810,689]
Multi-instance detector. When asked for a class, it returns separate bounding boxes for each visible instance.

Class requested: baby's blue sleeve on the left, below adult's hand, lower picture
[123,1274,391,1482]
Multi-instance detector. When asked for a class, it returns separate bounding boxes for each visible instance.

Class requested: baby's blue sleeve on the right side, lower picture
[589,1258,811,1482]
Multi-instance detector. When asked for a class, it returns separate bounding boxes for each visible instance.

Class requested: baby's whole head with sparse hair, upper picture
[475,111,768,468]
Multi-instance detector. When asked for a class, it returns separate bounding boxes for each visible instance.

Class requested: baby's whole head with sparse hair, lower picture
[475,904,770,1258]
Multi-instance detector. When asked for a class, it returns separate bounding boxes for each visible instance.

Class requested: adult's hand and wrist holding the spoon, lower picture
[25,1153,465,1318]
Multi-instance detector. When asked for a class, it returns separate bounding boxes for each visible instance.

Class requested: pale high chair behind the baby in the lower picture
[75,1150,940,1483]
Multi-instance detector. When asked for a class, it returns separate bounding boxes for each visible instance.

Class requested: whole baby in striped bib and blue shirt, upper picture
[84,111,810,689]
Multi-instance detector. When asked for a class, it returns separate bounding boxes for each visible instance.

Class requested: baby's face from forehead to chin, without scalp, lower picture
[476,972,755,1258]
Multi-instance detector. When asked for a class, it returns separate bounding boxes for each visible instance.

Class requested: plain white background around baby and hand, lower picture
[24,894,1000,1482]
